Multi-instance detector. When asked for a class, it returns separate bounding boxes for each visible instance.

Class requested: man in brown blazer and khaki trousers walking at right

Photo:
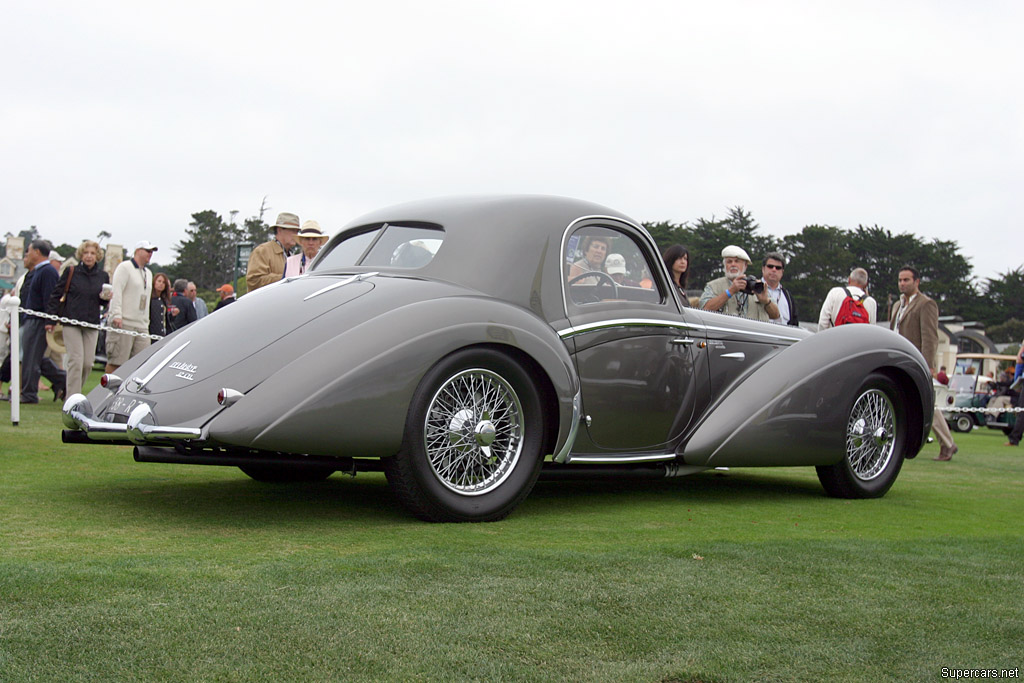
[889,265,959,461]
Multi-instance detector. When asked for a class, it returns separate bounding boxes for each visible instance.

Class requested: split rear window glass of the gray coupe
[311,223,444,271]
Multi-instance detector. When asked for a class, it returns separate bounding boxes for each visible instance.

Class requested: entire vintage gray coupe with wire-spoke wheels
[63,197,933,521]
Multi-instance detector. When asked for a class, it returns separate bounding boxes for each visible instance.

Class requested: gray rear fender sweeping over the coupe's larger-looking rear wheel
[209,295,579,457]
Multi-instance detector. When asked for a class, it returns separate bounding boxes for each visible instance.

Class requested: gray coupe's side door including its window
[563,219,706,456]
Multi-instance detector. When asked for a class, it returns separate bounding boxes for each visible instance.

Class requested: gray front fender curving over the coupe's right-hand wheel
[680,325,933,467]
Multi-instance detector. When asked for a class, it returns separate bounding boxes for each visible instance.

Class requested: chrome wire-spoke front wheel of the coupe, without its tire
[846,389,896,481]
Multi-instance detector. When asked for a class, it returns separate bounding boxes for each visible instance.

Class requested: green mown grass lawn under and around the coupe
[0,374,1024,681]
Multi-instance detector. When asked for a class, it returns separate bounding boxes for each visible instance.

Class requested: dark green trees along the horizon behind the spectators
[8,206,1024,342]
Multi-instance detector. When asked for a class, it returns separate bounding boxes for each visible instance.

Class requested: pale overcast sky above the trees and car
[0,0,1024,278]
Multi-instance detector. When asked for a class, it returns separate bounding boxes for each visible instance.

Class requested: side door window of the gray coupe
[563,225,666,305]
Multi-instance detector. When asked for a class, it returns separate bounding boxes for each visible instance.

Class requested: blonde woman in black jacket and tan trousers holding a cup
[46,240,111,395]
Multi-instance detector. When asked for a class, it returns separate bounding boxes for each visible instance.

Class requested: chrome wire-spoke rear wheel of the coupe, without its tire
[423,368,524,496]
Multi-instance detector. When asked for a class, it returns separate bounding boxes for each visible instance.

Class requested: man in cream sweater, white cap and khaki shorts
[106,240,157,373]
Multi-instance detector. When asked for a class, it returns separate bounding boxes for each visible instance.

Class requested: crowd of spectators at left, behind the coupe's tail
[0,213,329,404]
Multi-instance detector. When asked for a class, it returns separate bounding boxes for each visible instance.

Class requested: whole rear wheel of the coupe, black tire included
[384,348,547,522]
